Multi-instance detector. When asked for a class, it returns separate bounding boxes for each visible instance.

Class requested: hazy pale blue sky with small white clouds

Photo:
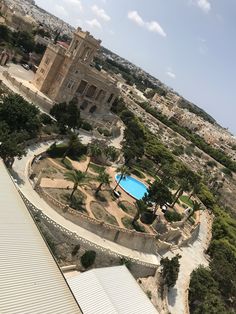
[36,0,236,134]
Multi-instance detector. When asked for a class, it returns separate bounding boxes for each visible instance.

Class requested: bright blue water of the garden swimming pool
[115,174,147,200]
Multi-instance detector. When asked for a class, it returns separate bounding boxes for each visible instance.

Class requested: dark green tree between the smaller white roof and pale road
[160,254,181,288]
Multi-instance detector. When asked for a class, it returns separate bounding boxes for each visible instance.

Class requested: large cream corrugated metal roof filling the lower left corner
[0,160,81,314]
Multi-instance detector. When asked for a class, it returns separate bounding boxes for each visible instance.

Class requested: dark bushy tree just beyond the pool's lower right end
[146,181,172,213]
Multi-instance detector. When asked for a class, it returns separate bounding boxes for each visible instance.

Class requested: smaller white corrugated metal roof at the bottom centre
[68,266,157,314]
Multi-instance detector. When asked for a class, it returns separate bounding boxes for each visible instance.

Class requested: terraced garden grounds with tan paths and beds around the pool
[31,142,198,235]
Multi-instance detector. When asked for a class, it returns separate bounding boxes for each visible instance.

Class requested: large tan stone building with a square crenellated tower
[33,28,119,113]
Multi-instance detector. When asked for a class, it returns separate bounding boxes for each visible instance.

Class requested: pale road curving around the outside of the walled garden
[12,139,211,314]
